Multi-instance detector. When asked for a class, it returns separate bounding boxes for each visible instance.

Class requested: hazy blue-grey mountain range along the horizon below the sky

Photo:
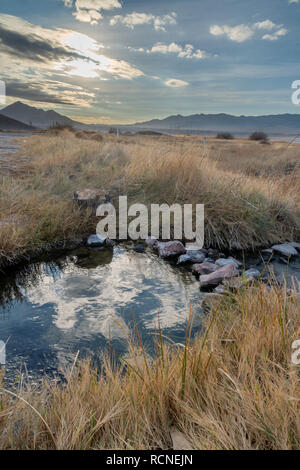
[0,101,300,136]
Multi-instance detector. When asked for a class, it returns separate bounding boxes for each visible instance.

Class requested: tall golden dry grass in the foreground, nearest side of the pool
[0,285,300,450]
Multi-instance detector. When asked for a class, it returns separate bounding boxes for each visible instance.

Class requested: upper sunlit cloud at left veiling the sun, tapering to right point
[0,14,143,79]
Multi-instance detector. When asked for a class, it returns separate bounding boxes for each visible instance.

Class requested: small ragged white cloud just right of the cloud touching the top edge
[110,11,177,31]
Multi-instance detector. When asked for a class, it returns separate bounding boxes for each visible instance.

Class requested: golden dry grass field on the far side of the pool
[0,130,300,259]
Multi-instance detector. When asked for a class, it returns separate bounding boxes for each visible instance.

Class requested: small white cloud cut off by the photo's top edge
[63,0,122,24]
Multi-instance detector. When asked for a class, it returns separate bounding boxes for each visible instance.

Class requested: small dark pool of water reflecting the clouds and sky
[0,246,202,380]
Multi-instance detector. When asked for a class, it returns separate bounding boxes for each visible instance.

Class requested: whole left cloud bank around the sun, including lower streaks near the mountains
[0,14,144,107]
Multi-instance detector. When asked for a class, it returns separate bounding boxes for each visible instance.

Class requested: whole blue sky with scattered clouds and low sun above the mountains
[0,0,300,124]
